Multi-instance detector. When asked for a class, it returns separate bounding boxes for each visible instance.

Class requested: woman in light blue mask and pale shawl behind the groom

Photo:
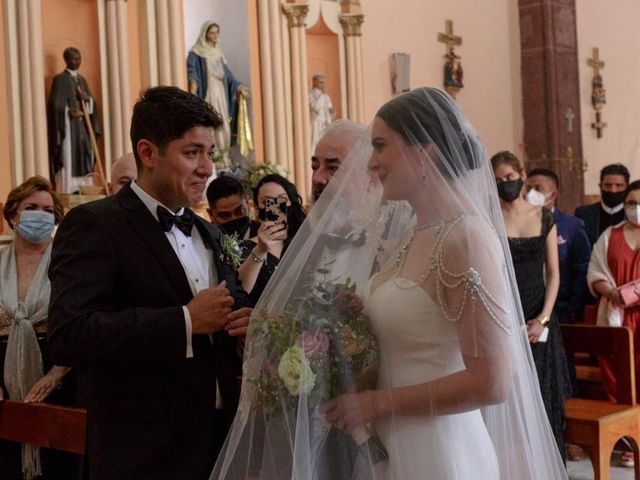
[0,177,74,480]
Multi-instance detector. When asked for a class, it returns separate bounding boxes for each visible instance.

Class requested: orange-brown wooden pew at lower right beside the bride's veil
[561,325,640,480]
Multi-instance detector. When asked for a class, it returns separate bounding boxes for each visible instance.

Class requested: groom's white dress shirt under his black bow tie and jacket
[131,180,218,358]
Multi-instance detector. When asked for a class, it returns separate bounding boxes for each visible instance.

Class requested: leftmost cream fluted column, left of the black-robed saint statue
[5,0,49,185]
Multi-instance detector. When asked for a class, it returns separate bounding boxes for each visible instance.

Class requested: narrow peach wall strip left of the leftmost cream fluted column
[0,2,13,208]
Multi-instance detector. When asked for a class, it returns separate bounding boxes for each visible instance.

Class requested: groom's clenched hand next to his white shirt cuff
[187,281,234,334]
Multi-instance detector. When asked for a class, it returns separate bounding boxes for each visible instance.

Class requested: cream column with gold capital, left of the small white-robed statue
[283,3,311,200]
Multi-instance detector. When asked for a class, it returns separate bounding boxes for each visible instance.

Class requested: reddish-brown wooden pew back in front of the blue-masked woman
[0,400,87,454]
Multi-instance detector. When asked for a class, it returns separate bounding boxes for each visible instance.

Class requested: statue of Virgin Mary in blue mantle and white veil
[187,21,251,161]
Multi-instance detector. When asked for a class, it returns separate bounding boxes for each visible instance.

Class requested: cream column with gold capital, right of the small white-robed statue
[340,13,365,122]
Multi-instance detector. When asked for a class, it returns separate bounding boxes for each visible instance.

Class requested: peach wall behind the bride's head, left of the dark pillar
[362,0,523,155]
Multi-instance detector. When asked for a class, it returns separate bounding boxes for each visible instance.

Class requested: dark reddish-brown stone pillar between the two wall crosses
[518,0,584,212]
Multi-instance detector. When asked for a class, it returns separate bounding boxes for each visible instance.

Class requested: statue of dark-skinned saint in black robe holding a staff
[49,47,100,193]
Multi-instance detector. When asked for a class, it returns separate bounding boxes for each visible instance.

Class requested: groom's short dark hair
[129,86,222,171]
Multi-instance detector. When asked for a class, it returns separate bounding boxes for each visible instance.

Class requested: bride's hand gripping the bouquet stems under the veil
[321,390,384,434]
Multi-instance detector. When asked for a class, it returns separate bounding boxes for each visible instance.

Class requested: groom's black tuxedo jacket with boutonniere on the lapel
[48,187,248,480]
